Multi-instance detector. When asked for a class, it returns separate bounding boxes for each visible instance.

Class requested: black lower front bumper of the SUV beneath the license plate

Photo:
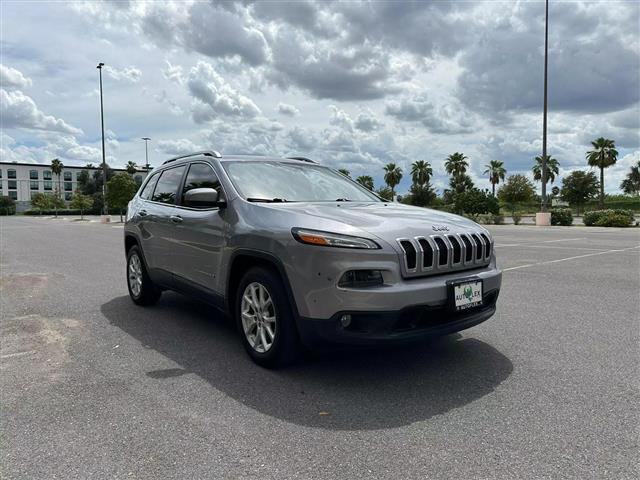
[298,289,500,348]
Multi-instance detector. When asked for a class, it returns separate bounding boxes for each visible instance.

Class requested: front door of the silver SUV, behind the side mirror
[172,162,227,294]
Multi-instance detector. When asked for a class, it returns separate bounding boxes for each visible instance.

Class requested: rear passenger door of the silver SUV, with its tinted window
[145,165,186,272]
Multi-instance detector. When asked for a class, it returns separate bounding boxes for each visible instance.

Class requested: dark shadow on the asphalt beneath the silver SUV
[101,293,513,430]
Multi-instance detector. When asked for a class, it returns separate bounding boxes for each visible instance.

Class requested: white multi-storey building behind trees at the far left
[0,162,148,212]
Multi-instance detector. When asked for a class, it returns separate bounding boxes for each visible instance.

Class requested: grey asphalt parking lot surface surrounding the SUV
[0,217,640,479]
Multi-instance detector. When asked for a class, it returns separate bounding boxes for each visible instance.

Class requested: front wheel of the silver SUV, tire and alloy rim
[235,267,300,368]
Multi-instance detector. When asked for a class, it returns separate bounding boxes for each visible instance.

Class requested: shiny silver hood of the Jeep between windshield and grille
[260,202,485,243]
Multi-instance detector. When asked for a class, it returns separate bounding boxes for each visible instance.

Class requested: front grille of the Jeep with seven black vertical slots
[398,232,492,277]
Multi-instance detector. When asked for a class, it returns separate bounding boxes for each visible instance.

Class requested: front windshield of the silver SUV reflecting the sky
[222,161,380,202]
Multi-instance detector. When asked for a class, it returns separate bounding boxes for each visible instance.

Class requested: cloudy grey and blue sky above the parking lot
[0,0,640,192]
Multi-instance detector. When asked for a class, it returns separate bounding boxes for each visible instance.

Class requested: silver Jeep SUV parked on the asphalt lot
[124,151,502,367]
